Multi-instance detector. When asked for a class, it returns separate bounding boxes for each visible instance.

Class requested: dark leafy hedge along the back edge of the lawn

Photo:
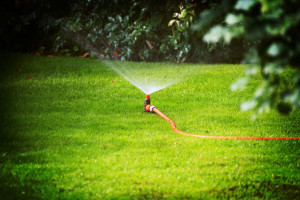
[0,0,245,63]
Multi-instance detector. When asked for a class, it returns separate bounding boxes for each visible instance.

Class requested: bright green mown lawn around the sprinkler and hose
[0,54,300,199]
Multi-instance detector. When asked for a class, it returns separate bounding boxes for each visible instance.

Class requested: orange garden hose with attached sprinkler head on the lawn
[144,94,300,140]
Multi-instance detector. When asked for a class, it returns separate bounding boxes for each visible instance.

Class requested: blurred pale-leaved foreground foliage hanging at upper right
[194,0,300,114]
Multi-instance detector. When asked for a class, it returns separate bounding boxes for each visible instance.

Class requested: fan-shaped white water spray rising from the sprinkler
[67,31,190,94]
